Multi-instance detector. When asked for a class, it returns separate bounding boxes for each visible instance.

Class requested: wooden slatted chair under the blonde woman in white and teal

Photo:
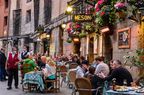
[44,65,60,92]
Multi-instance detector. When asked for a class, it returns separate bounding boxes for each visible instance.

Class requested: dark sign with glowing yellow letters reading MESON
[73,14,93,22]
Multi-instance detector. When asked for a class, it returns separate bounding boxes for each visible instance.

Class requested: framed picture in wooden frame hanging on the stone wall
[118,27,131,49]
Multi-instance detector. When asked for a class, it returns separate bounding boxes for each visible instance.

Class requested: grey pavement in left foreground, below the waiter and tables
[0,81,72,95]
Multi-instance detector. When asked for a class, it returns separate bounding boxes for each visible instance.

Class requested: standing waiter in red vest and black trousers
[7,47,19,90]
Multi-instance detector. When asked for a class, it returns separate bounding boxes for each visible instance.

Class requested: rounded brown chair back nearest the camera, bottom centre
[75,78,92,95]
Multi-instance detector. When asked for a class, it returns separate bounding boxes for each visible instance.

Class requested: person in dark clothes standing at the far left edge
[0,48,6,81]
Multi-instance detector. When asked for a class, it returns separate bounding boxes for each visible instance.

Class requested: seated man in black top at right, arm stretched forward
[98,60,133,86]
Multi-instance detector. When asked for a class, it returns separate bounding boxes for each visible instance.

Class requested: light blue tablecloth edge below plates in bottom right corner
[106,90,144,95]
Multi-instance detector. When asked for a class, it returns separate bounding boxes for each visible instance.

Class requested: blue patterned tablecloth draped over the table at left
[23,72,44,91]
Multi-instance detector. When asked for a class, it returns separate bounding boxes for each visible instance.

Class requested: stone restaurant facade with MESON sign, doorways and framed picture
[42,0,144,78]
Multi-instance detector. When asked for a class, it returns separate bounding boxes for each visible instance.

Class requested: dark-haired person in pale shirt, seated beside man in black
[95,57,109,76]
